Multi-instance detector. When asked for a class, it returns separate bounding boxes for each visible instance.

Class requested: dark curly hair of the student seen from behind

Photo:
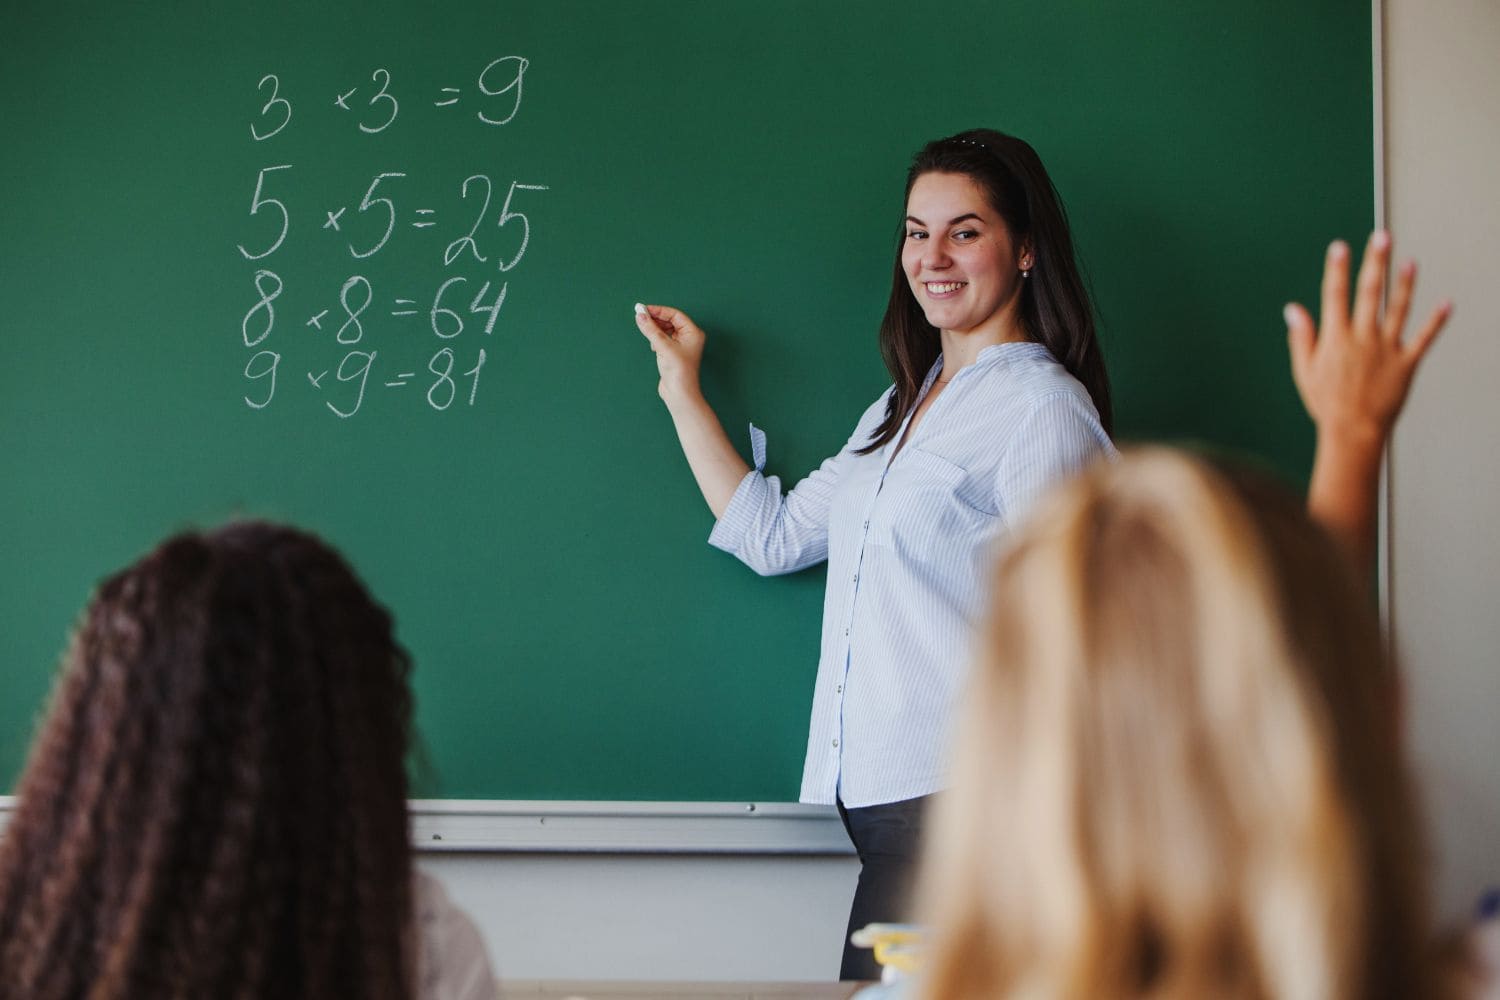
[0,522,416,1000]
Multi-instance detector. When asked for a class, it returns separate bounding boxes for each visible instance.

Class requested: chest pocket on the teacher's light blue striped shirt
[870,445,999,567]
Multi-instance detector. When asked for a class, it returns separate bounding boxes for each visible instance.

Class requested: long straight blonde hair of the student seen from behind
[921,448,1436,1000]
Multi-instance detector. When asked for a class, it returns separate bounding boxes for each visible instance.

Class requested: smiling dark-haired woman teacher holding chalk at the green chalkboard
[636,129,1113,979]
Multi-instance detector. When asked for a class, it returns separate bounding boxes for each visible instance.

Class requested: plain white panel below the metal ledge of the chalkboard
[419,853,858,981]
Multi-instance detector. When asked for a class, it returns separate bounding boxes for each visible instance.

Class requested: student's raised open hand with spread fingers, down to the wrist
[1286,231,1452,453]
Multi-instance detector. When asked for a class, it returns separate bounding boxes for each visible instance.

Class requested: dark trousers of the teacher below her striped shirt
[839,795,932,979]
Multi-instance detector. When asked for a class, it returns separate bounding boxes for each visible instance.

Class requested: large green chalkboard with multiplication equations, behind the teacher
[0,0,1373,801]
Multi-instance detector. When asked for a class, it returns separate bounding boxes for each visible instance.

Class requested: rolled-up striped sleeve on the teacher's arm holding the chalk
[708,424,848,576]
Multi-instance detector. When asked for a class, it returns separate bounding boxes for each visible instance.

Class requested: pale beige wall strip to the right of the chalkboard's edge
[1385,0,1500,916]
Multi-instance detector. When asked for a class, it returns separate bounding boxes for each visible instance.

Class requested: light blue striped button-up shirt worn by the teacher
[708,343,1113,808]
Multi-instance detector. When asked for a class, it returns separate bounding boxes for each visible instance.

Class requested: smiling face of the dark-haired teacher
[902,174,1031,339]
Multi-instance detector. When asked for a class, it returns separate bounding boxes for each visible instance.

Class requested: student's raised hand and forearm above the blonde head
[1286,231,1452,573]
